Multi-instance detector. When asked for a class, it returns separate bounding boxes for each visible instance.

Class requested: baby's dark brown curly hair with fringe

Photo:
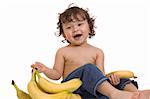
[57,6,95,42]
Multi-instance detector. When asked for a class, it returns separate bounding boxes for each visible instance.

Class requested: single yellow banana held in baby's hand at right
[106,70,137,78]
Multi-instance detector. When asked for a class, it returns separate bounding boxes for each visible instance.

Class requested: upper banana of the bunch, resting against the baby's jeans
[36,71,82,93]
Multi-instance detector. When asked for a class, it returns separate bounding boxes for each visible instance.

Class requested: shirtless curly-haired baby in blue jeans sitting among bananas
[31,6,150,99]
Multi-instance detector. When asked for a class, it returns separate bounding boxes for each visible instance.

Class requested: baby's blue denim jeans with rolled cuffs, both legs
[62,64,137,99]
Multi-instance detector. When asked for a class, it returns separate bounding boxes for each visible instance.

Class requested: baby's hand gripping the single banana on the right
[108,74,120,85]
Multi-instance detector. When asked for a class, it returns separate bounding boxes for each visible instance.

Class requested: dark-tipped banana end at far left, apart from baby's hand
[11,80,32,99]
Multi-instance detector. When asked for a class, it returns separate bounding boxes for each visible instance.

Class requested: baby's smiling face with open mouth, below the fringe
[63,17,90,45]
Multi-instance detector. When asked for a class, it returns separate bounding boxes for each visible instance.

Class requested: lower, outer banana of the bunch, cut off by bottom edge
[27,70,71,99]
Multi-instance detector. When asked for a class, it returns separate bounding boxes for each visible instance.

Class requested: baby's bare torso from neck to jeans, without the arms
[63,45,103,78]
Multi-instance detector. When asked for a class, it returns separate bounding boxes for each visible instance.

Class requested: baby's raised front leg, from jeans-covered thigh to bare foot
[63,64,150,99]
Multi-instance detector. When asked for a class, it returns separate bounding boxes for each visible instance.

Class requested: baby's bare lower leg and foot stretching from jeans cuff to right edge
[97,81,150,99]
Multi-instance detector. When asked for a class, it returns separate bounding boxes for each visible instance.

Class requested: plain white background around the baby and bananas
[0,0,150,99]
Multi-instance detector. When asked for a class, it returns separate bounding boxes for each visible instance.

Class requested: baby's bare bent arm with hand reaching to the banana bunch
[31,49,64,80]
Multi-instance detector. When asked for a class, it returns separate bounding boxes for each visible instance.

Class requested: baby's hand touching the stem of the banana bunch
[31,62,46,72]
